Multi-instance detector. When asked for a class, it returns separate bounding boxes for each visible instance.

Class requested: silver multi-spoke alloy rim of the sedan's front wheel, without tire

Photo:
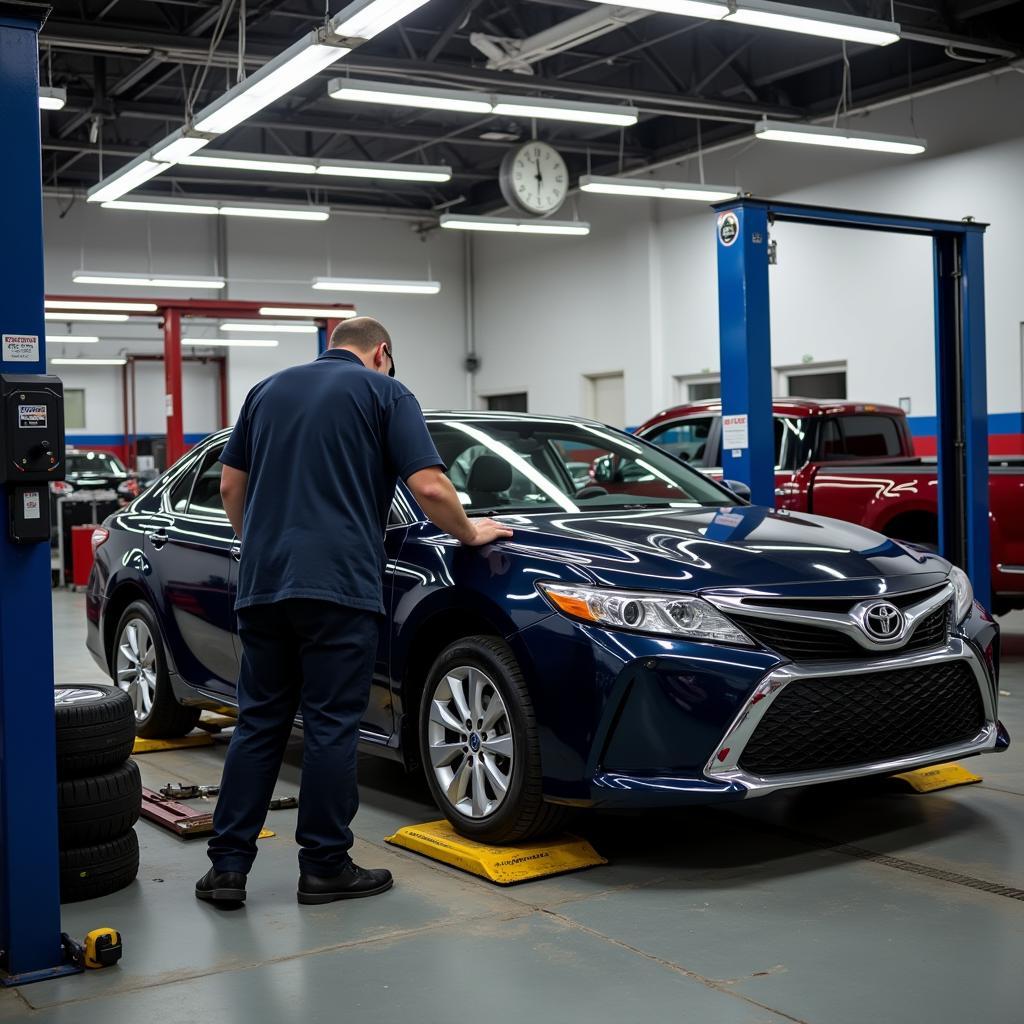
[427,666,515,818]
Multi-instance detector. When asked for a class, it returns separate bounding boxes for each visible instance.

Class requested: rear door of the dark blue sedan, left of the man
[145,440,239,696]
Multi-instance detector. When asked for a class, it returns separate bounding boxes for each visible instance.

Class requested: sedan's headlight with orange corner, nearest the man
[537,583,754,647]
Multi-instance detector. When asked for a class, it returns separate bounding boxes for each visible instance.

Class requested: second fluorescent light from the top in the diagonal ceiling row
[195,29,351,135]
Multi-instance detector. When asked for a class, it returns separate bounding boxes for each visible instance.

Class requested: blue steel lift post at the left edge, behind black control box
[0,2,79,984]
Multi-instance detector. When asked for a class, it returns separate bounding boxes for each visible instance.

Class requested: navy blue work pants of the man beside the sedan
[209,600,380,878]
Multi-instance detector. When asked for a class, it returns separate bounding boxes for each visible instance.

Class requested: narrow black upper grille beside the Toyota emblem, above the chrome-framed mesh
[729,601,949,662]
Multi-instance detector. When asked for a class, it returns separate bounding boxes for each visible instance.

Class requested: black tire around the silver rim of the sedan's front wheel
[420,636,566,845]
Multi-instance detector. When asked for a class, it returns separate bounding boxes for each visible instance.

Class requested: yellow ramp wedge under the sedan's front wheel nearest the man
[385,821,607,886]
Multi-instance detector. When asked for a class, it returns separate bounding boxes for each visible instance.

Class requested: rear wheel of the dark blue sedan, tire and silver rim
[111,601,200,738]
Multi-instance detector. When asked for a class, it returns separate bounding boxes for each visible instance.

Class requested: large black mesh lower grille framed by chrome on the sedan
[739,662,985,775]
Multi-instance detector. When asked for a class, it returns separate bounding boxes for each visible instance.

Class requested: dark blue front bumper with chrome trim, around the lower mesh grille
[513,612,1010,808]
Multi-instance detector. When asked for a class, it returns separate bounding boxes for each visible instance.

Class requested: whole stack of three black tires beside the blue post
[53,684,142,903]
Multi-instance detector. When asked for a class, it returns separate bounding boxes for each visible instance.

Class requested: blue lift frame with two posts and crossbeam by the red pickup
[715,198,991,606]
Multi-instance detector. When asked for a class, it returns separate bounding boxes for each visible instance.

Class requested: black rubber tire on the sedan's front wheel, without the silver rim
[420,636,565,844]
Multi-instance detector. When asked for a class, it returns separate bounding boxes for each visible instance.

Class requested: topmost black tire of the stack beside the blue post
[53,685,135,779]
